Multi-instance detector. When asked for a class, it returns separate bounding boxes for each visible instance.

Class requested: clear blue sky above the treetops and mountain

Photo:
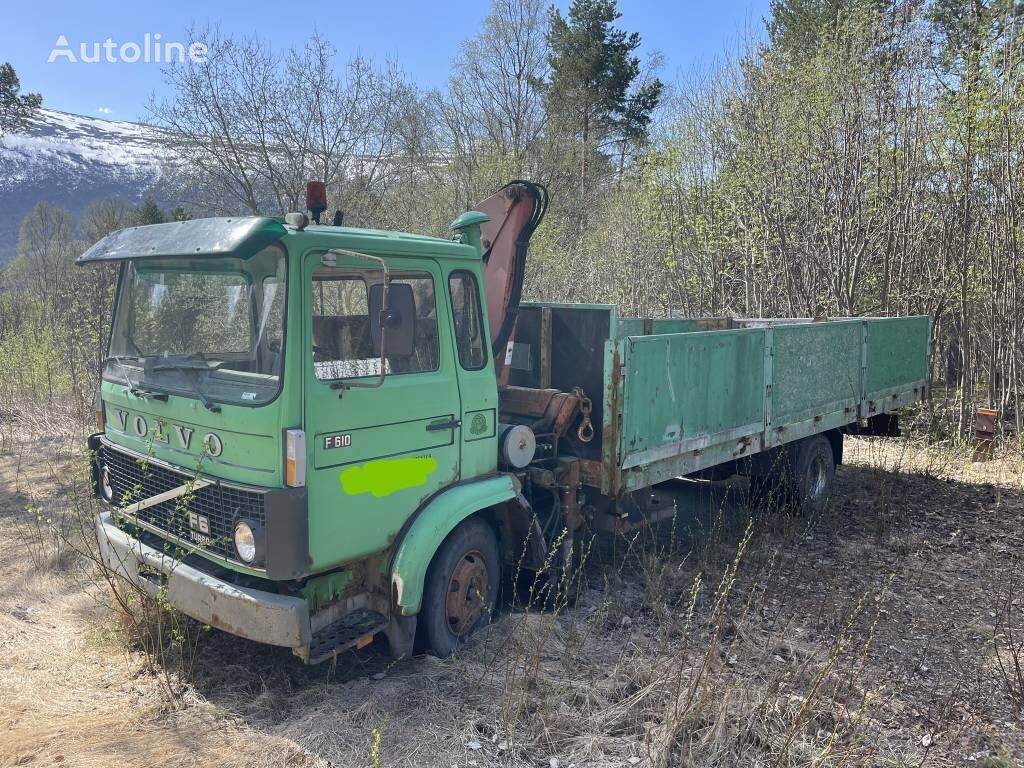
[0,0,769,121]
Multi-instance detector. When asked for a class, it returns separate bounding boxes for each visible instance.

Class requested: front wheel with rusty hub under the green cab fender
[420,517,502,658]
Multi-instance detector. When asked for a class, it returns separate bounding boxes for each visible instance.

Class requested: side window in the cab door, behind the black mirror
[312,267,438,381]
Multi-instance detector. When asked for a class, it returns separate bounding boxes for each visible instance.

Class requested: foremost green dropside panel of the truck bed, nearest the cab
[620,329,765,466]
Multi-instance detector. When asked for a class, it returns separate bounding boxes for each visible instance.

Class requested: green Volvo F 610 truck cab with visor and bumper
[86,207,528,662]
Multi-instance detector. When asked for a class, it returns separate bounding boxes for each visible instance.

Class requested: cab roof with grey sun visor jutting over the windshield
[77,216,479,264]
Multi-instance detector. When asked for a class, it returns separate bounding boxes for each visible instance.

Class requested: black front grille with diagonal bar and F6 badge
[101,444,265,561]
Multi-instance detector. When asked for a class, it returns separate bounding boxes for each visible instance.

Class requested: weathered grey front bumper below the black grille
[96,512,312,656]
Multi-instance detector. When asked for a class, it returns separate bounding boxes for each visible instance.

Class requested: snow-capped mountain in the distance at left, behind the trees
[0,110,165,263]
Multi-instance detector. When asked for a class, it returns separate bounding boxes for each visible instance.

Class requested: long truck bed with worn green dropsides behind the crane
[510,304,931,497]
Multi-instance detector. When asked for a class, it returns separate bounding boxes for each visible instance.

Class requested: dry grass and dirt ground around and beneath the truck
[0,438,1024,768]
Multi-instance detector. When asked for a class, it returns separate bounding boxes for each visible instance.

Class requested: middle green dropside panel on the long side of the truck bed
[771,321,863,425]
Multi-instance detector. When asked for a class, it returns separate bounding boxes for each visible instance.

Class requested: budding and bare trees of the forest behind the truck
[0,0,1024,439]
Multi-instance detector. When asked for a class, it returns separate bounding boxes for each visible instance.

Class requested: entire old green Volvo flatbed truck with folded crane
[78,181,931,664]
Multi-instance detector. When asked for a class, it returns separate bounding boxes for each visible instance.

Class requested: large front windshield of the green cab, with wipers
[103,245,286,410]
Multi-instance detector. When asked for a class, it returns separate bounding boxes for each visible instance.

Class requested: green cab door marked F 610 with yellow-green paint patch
[303,253,462,568]
